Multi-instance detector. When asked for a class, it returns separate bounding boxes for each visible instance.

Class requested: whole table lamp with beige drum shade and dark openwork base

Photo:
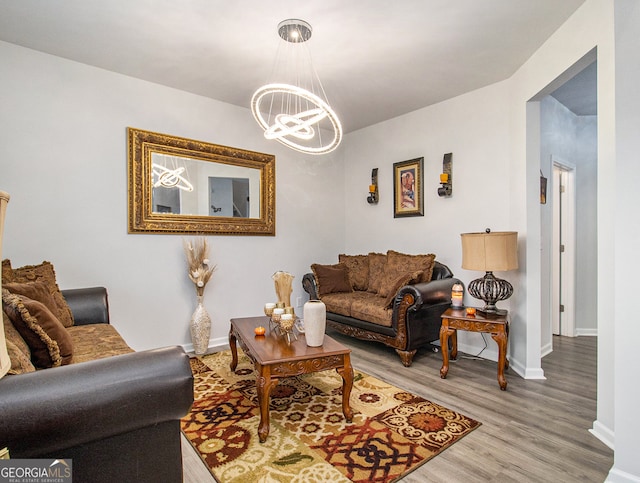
[460,228,518,315]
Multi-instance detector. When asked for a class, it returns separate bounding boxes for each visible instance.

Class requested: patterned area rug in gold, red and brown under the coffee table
[182,349,480,483]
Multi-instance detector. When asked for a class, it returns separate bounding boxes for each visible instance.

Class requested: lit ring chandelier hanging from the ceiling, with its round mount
[251,19,342,154]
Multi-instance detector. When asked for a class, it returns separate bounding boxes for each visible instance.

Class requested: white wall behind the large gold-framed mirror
[0,42,344,350]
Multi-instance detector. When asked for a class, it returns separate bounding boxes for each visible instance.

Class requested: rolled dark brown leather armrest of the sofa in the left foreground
[0,346,193,458]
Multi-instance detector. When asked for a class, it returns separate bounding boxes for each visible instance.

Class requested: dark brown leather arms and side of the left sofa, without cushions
[0,288,193,483]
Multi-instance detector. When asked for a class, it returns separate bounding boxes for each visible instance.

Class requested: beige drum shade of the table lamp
[460,231,518,272]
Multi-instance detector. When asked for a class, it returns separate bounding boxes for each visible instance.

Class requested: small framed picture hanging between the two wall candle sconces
[393,158,424,218]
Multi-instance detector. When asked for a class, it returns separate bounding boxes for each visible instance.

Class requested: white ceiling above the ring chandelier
[0,0,584,132]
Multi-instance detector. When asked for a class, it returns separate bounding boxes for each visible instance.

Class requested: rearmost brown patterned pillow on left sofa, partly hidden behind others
[2,260,73,327]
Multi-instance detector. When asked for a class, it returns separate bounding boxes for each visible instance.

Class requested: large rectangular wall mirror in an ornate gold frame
[127,127,276,236]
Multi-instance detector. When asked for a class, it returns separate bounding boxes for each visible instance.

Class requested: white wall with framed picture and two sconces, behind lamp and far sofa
[344,83,512,360]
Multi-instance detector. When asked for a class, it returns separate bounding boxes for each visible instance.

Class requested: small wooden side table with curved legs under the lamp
[440,308,509,391]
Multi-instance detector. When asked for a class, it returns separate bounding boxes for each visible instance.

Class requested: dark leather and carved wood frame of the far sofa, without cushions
[302,262,461,367]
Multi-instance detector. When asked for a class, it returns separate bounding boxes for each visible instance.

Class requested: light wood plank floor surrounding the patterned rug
[183,332,613,483]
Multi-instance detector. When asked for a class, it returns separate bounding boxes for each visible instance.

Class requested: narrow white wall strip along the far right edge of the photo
[598,0,640,483]
